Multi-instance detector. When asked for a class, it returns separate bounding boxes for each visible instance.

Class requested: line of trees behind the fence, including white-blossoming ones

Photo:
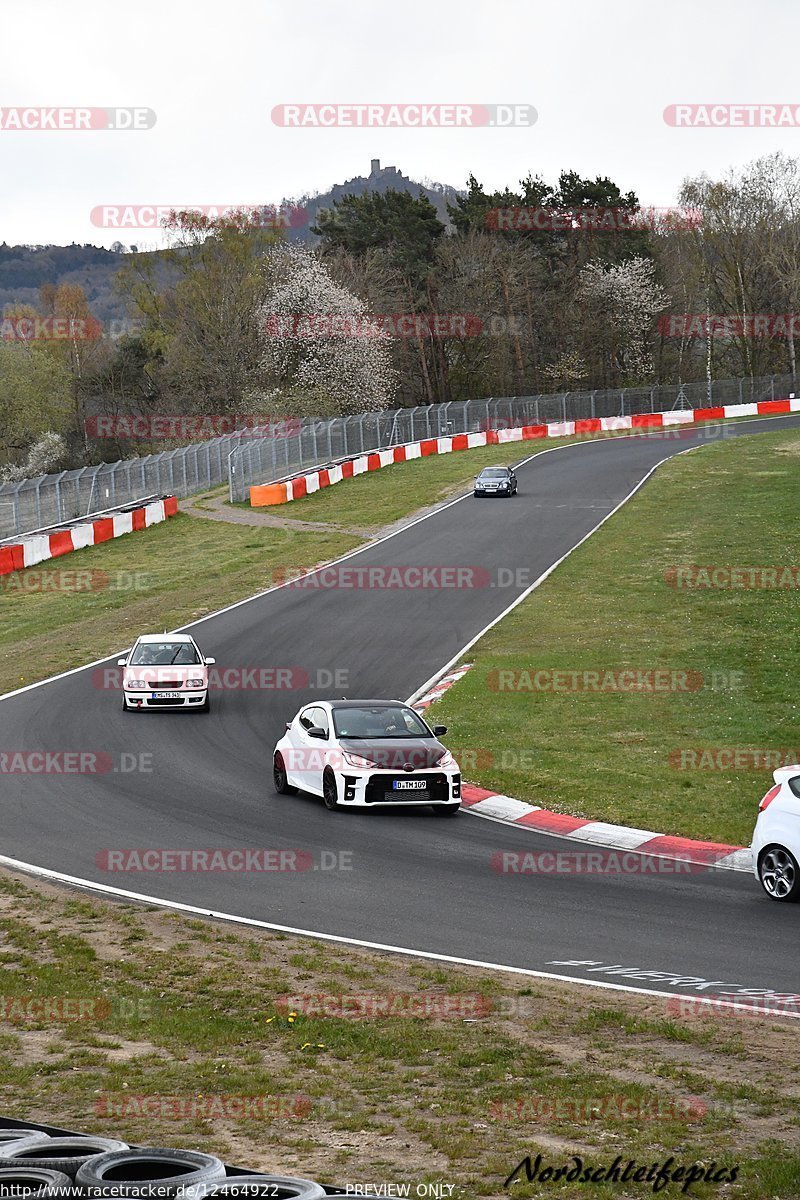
[0,152,800,478]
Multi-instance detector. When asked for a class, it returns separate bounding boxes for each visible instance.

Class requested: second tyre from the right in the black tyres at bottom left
[76,1146,225,1200]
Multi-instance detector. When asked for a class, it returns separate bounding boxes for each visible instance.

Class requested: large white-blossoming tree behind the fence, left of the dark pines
[248,245,397,416]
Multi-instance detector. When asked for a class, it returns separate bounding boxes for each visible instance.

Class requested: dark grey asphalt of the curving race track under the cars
[0,416,800,996]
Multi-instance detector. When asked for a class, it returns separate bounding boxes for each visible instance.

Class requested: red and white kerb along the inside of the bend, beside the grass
[411,662,752,872]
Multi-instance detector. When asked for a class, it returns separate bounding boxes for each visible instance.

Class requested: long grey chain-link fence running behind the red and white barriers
[0,376,795,540]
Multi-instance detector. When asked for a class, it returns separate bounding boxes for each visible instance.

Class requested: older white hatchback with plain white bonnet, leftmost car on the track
[116,634,216,713]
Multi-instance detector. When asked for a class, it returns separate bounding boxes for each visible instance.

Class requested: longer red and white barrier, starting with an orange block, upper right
[249,400,800,508]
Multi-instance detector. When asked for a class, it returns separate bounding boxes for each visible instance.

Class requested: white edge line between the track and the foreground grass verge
[0,854,800,1019]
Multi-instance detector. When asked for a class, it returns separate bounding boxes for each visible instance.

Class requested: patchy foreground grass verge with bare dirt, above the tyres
[0,871,800,1200]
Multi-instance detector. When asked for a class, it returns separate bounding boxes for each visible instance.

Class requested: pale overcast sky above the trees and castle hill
[0,0,800,246]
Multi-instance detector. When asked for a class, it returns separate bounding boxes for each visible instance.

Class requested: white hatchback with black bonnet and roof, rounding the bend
[272,700,461,816]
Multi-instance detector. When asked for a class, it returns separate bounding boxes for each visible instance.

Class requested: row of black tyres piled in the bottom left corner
[0,1126,383,1200]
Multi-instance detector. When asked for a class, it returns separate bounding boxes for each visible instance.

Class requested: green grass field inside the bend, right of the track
[435,430,800,845]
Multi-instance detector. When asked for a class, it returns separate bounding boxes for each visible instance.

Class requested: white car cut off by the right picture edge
[752,766,800,901]
